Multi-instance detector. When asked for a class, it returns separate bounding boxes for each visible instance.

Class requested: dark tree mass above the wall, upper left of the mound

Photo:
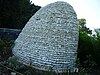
[0,0,40,29]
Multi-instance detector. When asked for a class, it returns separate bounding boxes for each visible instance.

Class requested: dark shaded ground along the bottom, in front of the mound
[0,63,100,75]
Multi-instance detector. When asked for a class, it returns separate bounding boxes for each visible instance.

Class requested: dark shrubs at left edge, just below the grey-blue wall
[0,39,14,60]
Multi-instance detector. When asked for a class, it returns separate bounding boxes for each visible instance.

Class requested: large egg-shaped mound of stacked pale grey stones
[13,2,78,73]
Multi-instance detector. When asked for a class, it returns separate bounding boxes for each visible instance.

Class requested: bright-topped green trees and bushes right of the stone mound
[77,19,100,71]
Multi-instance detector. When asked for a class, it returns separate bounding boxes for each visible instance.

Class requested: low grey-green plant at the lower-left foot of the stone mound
[0,56,25,75]
